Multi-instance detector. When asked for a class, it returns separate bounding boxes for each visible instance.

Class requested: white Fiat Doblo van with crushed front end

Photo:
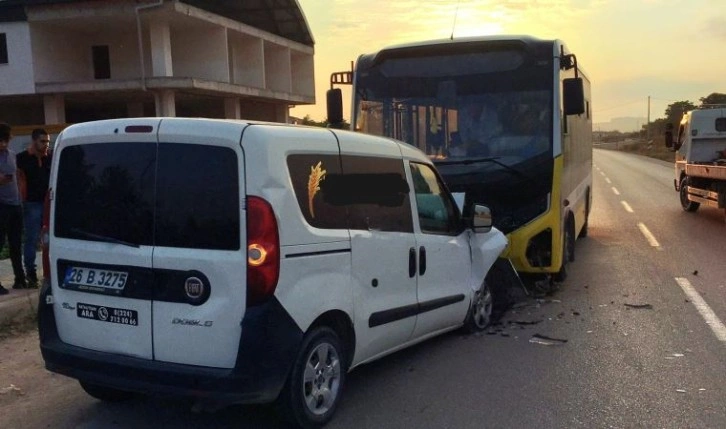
[39,118,506,427]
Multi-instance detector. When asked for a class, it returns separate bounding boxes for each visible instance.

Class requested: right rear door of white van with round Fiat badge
[153,119,247,368]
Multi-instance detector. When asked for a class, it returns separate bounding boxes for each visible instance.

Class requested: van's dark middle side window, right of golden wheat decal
[342,155,413,232]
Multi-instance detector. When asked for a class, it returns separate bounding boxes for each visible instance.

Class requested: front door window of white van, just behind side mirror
[411,163,461,234]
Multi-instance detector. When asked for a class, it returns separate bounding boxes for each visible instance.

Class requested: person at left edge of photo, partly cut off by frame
[0,122,27,295]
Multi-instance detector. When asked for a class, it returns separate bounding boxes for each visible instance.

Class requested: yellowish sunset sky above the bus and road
[291,0,726,124]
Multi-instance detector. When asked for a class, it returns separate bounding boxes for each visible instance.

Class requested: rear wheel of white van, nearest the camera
[278,326,346,428]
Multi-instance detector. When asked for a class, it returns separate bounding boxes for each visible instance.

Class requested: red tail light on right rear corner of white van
[247,197,280,307]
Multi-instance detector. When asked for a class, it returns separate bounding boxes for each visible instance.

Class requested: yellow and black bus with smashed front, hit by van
[328,36,592,280]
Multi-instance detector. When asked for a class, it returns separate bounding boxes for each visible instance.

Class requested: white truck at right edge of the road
[665,105,726,217]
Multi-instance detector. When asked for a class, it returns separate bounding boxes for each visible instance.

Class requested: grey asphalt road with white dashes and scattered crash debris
[0,150,726,429]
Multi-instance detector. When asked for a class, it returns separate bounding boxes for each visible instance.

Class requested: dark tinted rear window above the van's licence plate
[55,143,156,245]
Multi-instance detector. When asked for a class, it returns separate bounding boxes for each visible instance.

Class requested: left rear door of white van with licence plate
[49,119,159,359]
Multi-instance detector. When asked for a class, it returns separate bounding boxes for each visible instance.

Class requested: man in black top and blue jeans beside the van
[16,128,50,287]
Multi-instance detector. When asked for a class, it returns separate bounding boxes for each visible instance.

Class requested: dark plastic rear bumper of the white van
[38,286,303,404]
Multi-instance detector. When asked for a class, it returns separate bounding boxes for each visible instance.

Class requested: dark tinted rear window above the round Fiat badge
[156,143,241,250]
